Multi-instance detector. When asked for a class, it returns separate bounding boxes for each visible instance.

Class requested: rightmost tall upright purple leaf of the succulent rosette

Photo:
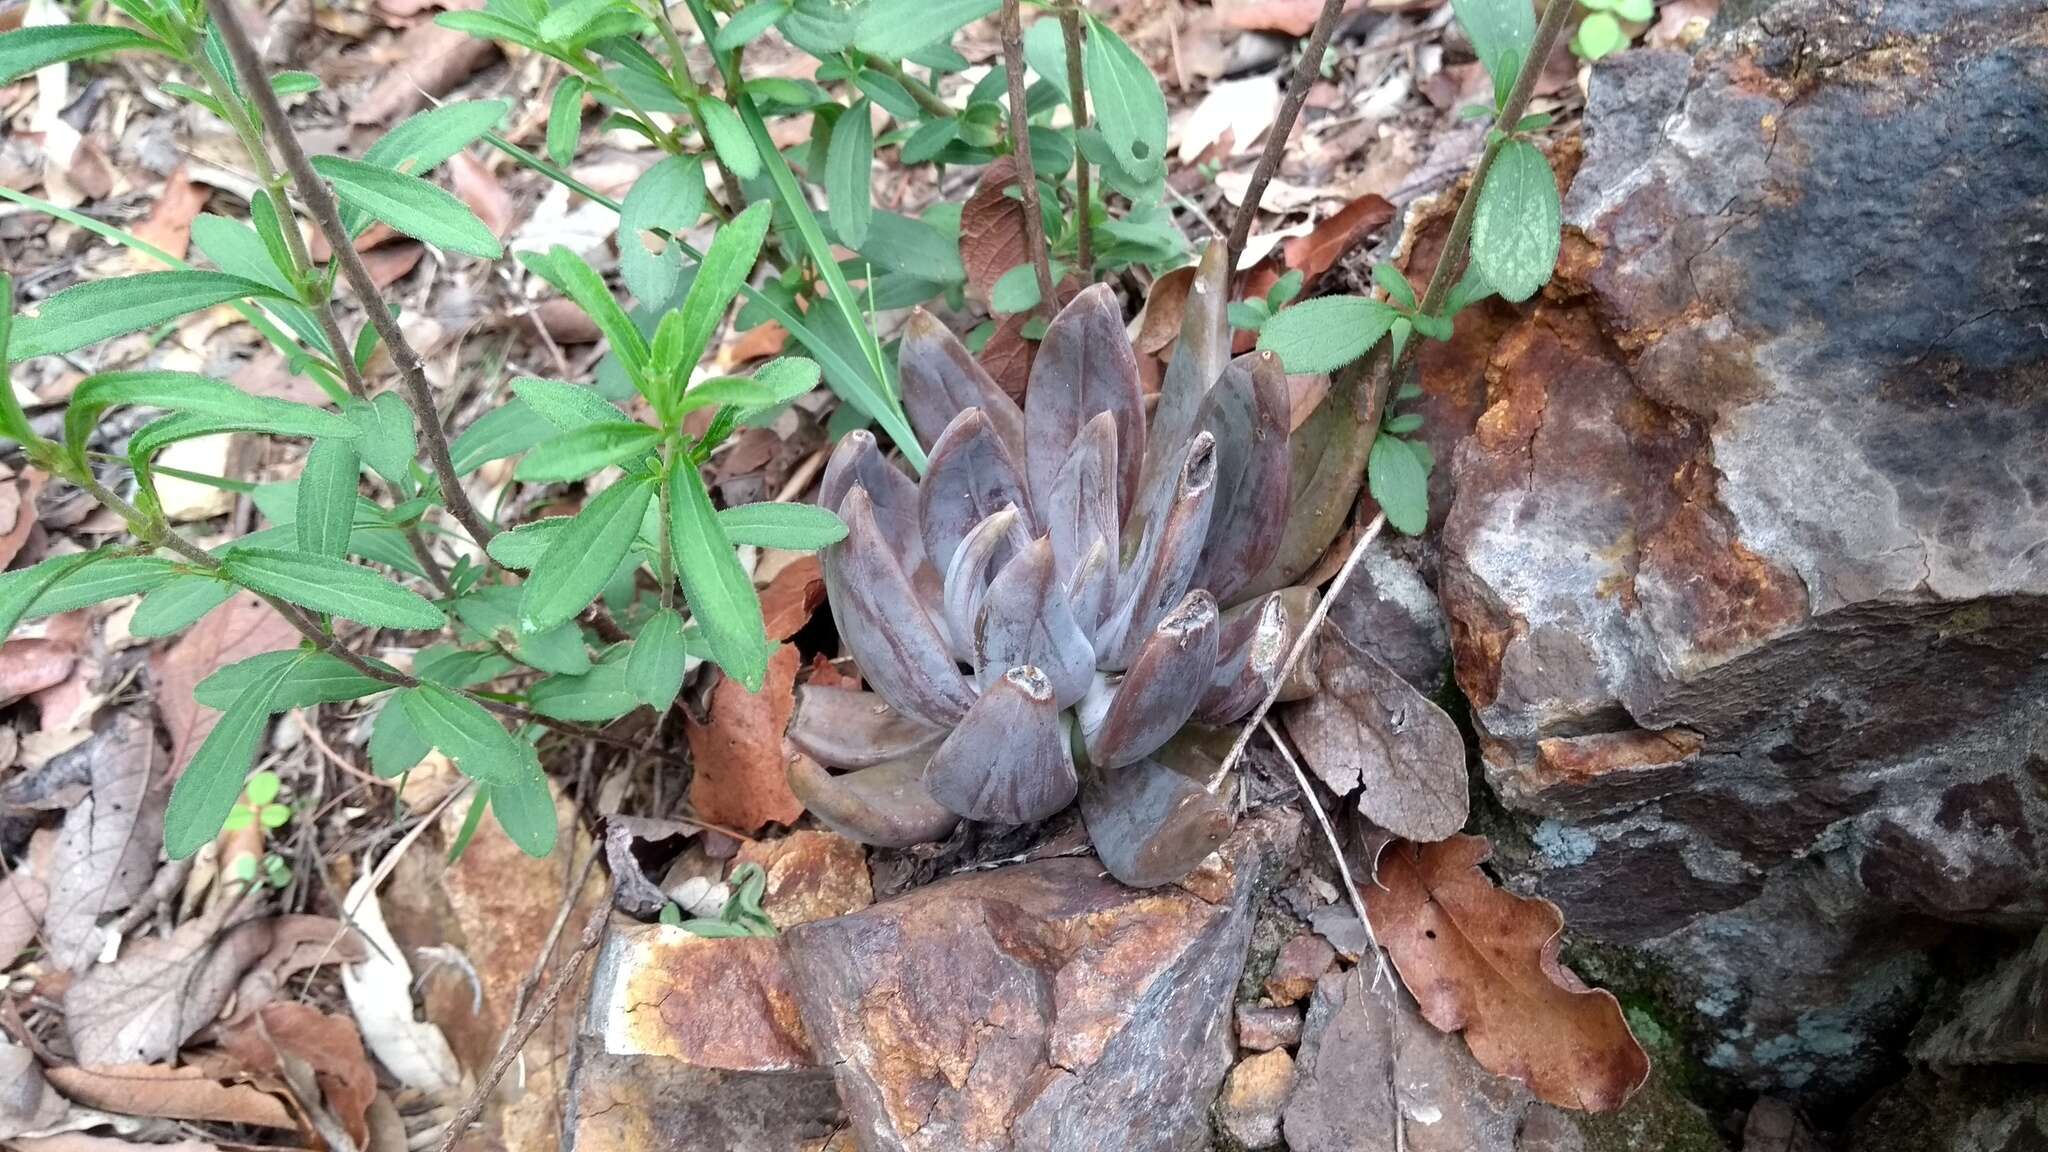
[1194,353,1288,605]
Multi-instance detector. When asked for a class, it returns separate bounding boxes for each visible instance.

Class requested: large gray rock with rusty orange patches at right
[1440,0,2048,1099]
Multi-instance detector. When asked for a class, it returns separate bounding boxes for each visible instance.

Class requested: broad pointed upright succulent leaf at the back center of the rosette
[1024,285,1145,523]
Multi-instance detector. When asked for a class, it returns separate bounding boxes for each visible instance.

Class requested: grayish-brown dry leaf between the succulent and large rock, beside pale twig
[1286,629,1468,840]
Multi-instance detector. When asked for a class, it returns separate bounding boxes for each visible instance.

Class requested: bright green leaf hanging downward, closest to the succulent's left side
[668,465,768,693]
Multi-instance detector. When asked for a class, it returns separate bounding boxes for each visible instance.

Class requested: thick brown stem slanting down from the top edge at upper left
[207,0,498,547]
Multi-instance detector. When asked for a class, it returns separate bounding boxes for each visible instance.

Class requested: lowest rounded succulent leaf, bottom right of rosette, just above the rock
[1081,756,1235,888]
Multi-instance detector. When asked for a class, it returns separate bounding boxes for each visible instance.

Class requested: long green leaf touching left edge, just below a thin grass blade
[6,269,285,361]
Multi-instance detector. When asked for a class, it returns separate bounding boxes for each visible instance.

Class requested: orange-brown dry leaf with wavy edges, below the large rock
[1362,836,1651,1111]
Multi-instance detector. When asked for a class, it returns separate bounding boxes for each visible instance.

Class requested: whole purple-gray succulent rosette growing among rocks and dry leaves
[788,250,1303,886]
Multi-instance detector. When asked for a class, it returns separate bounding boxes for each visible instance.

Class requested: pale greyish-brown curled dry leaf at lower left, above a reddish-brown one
[63,897,274,1064]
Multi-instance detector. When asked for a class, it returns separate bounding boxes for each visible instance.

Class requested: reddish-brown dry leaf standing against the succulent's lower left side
[684,644,803,836]
